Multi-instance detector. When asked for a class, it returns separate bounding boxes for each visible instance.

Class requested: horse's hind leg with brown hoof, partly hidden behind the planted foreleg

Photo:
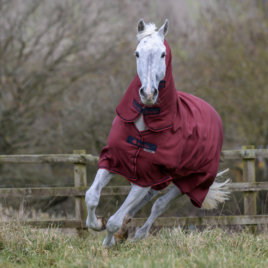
[114,189,158,242]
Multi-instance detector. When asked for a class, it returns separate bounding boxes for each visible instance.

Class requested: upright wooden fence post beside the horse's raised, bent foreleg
[73,150,87,231]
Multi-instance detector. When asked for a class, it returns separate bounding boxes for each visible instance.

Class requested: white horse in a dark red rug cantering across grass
[85,19,229,247]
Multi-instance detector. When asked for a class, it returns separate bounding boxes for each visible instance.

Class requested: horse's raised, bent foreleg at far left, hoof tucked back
[85,169,115,231]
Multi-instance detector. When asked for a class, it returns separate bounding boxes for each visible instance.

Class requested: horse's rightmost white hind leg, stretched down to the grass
[134,185,182,240]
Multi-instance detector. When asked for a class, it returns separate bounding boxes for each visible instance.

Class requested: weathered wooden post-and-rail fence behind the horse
[0,146,268,229]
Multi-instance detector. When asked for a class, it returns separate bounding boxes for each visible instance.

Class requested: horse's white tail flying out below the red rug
[202,169,230,209]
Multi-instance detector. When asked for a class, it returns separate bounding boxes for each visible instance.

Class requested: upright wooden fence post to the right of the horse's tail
[242,145,257,234]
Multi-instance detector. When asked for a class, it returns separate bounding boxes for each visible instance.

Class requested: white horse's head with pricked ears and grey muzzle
[134,20,168,105]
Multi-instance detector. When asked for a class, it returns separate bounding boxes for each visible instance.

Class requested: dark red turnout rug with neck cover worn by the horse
[98,40,223,208]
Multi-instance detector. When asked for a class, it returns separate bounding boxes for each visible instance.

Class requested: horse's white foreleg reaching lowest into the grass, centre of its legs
[103,185,150,247]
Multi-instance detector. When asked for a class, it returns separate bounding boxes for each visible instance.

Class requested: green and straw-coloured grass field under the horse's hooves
[0,222,268,268]
